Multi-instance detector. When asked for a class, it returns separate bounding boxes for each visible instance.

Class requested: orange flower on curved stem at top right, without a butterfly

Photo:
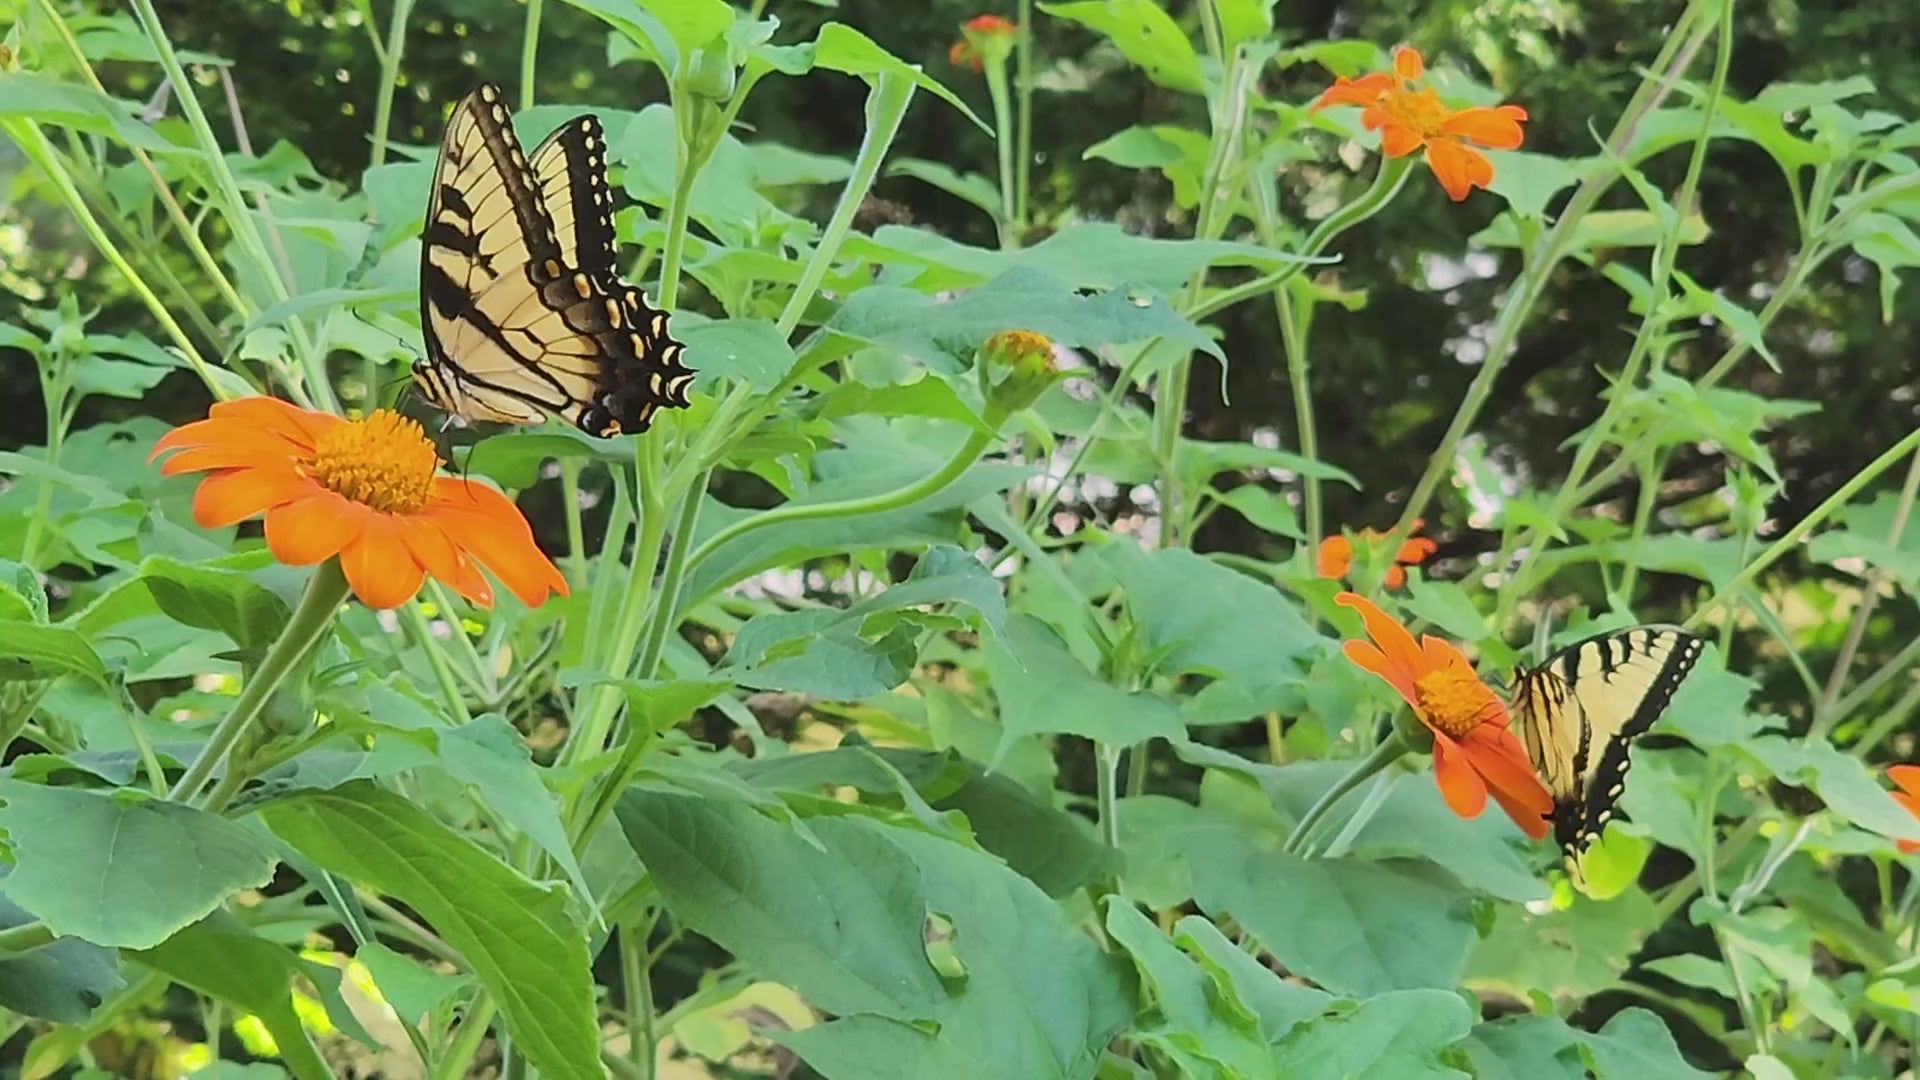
[1313,46,1526,202]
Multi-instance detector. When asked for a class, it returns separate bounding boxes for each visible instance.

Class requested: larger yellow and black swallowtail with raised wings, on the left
[413,83,693,438]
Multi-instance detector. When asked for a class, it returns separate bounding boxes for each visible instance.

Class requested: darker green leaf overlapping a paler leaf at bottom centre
[614,788,947,1020]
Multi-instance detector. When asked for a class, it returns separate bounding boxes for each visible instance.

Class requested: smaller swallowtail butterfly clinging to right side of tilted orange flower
[1513,626,1705,878]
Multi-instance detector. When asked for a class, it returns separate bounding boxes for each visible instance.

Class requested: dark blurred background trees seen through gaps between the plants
[0,0,1920,607]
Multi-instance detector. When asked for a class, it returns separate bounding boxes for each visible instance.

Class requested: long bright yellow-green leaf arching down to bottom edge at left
[259,780,603,1080]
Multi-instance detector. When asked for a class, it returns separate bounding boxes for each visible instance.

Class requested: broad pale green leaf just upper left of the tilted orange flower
[1106,540,1325,696]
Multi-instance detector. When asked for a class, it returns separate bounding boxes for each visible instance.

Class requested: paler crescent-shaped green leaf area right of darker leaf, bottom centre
[778,819,1135,1080]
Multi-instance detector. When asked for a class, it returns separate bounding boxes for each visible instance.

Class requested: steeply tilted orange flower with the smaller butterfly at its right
[1334,592,1553,840]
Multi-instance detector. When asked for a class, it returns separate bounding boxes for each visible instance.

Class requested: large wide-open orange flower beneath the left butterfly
[148,398,566,607]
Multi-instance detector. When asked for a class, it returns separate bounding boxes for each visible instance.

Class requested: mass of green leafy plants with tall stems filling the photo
[0,0,1920,1078]
